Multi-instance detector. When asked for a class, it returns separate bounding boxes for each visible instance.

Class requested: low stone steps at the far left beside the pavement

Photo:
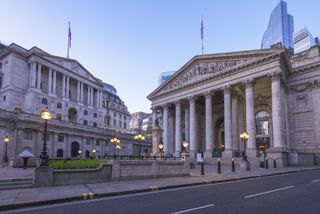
[0,177,32,191]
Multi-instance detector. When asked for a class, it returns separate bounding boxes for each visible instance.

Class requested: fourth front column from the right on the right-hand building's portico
[204,93,213,158]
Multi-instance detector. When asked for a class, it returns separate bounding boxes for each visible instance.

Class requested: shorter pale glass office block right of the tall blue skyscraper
[293,27,316,54]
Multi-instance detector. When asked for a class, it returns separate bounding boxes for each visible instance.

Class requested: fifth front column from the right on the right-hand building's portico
[189,97,197,158]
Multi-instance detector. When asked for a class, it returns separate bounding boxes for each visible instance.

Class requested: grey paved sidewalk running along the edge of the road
[0,165,320,210]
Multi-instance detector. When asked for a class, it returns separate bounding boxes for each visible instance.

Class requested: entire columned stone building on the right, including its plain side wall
[147,44,320,165]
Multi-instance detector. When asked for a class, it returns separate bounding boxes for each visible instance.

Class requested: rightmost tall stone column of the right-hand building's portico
[271,74,285,148]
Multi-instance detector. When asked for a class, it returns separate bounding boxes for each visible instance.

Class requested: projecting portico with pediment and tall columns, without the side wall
[148,48,288,164]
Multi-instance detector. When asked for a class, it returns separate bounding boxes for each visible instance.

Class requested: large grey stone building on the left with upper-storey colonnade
[0,44,148,160]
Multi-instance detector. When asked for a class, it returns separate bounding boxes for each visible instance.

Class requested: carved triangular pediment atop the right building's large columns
[148,48,284,99]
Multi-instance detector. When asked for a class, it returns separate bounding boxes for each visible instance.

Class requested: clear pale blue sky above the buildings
[0,0,320,113]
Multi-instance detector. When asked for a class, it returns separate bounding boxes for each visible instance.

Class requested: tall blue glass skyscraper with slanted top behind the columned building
[261,1,294,49]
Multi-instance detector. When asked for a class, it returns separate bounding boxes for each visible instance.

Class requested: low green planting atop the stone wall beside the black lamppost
[50,159,100,169]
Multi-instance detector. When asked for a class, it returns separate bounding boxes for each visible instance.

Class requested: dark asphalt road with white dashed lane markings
[6,170,320,214]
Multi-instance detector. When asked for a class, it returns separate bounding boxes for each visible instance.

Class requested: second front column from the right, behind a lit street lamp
[245,80,257,157]
